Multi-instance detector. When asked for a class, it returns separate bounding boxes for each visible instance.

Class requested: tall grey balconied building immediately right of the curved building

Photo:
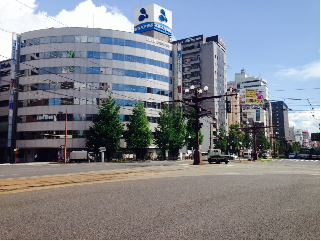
[172,35,228,134]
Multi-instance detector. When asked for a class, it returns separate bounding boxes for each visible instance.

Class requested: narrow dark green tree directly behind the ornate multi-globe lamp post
[185,108,204,150]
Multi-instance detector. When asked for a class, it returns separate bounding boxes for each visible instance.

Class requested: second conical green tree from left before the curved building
[125,101,153,160]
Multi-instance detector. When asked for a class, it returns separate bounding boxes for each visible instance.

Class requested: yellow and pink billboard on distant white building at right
[240,86,267,104]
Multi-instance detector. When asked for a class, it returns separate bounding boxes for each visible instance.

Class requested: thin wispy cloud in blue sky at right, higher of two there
[276,61,320,81]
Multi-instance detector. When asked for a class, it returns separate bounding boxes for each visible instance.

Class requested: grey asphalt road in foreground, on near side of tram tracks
[0,161,320,240]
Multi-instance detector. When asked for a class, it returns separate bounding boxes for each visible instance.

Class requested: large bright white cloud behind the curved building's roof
[0,0,134,60]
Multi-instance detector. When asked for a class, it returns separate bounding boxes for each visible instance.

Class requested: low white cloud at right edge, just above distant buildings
[289,109,320,133]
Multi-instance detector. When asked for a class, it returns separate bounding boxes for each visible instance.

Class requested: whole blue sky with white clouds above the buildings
[0,0,320,133]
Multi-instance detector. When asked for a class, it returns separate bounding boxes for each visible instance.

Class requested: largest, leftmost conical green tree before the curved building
[86,95,123,160]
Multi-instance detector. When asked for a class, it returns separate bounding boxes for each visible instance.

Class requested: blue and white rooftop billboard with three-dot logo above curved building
[134,4,172,36]
